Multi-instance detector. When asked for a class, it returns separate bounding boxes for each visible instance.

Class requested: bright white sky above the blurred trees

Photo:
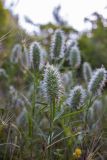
[7,0,107,31]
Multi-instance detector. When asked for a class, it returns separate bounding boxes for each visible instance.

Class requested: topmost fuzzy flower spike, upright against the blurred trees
[50,29,65,59]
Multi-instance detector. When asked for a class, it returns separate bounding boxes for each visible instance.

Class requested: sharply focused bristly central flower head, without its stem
[43,64,63,102]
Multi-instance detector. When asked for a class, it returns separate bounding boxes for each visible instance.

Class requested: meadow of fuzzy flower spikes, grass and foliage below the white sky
[0,0,107,160]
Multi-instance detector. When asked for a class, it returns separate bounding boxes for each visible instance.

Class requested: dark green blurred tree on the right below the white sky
[79,12,107,68]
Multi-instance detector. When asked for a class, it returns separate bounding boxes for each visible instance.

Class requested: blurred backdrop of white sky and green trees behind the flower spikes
[0,0,107,67]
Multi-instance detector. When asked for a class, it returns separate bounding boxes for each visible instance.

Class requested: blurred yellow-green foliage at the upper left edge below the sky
[0,1,32,65]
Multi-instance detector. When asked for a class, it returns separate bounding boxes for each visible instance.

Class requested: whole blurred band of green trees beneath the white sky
[0,1,107,68]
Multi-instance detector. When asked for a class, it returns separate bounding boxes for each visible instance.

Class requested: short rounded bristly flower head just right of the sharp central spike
[66,86,86,109]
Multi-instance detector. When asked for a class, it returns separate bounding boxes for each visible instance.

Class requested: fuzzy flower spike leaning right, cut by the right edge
[88,67,107,95]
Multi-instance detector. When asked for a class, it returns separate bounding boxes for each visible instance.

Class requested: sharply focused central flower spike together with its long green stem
[42,64,64,159]
